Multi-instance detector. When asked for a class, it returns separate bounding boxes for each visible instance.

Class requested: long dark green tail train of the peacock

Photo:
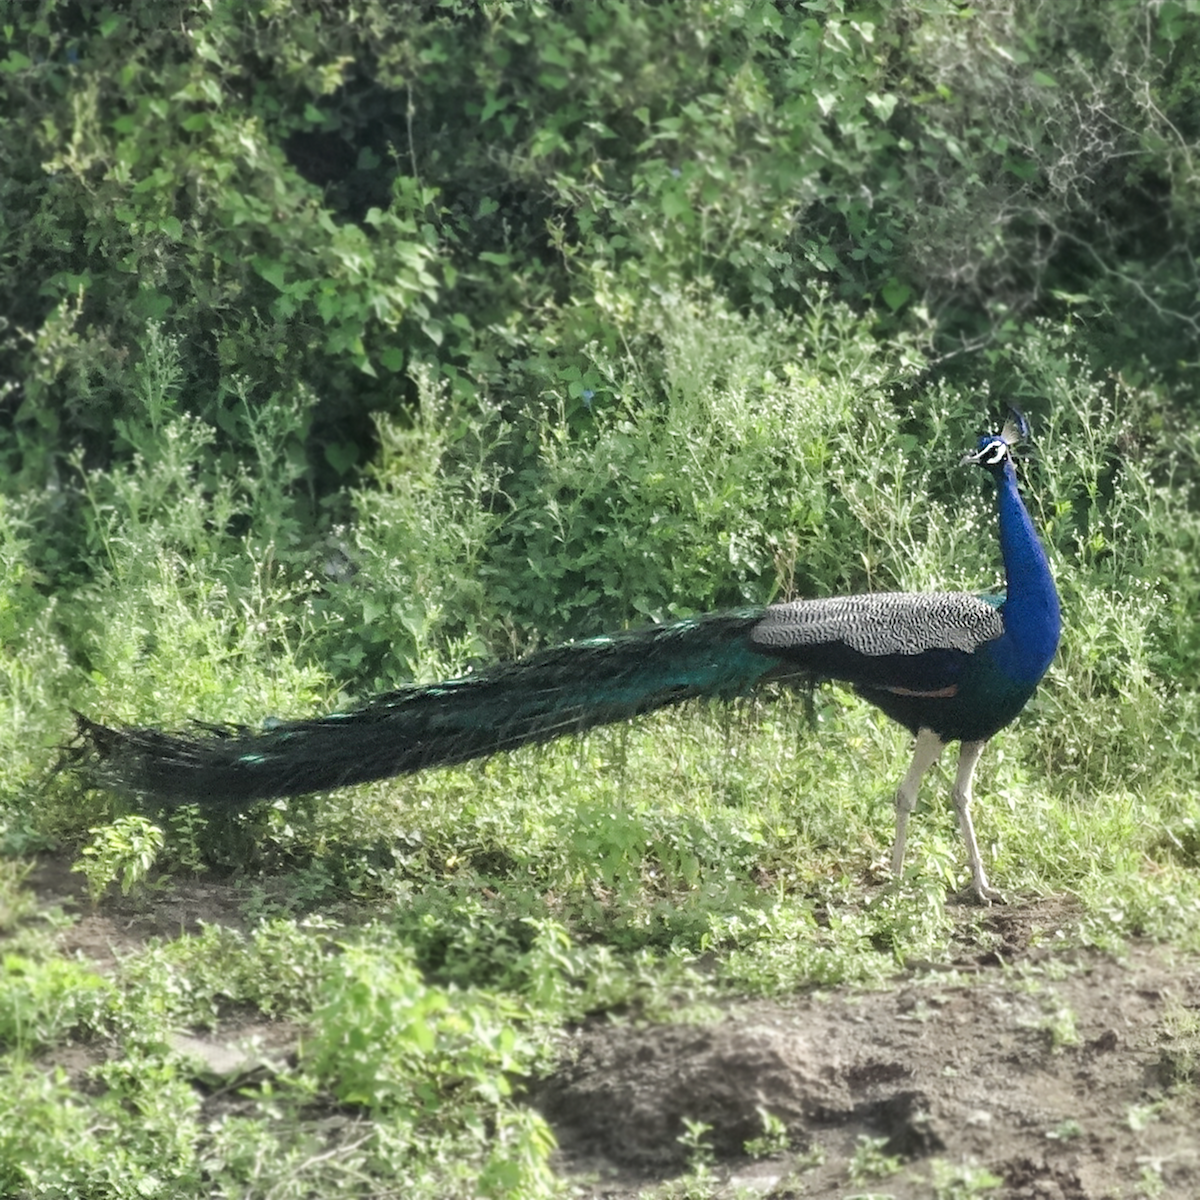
[78,610,778,806]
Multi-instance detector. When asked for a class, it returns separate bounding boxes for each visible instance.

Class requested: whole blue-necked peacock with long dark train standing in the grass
[79,413,1061,904]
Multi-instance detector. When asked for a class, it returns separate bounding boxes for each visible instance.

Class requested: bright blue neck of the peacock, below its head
[994,461,1062,684]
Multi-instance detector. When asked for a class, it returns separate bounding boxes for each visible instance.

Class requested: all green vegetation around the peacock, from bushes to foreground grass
[0,0,1200,1196]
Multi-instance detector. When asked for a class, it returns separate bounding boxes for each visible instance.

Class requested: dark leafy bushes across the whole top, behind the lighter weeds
[0,0,1200,487]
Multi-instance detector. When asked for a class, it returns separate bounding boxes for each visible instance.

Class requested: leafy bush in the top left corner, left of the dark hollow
[4,2,438,480]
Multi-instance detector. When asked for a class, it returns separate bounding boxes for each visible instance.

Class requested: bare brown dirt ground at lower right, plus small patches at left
[16,860,1200,1200]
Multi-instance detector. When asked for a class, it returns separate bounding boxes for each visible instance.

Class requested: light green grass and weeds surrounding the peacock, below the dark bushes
[0,307,1200,1200]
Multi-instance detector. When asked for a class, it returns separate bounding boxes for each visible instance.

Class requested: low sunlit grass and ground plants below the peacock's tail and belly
[0,698,1200,1196]
